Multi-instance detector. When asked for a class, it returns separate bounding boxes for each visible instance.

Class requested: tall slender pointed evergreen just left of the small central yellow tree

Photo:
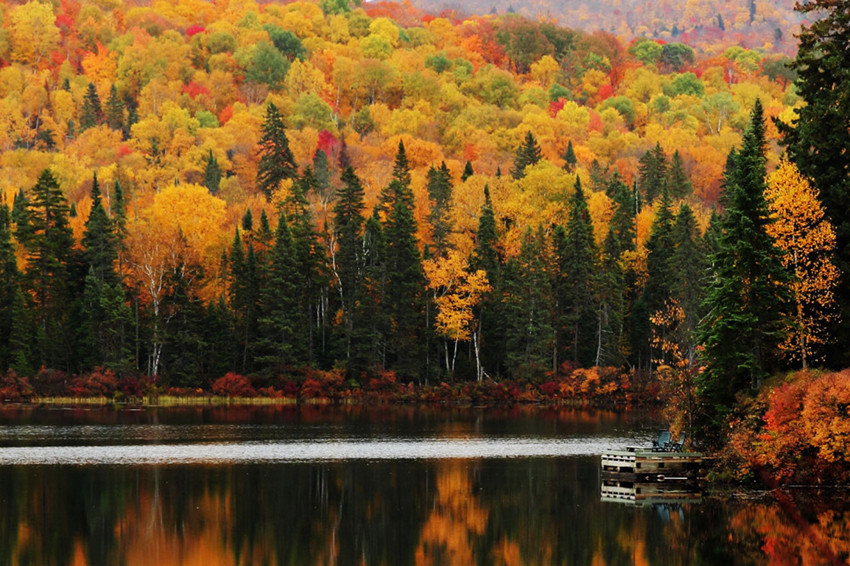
[384,142,425,378]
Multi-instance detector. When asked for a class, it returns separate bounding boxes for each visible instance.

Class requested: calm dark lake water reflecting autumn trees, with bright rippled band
[0,407,850,566]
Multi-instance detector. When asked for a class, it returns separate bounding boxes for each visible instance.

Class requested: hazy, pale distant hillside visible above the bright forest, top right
[412,0,803,55]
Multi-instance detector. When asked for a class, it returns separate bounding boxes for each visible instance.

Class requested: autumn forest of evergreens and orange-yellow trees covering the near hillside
[0,0,850,458]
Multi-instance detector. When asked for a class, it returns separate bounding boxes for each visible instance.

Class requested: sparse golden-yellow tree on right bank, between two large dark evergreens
[765,160,839,369]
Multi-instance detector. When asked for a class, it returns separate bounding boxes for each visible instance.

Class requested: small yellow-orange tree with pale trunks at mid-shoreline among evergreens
[422,254,491,381]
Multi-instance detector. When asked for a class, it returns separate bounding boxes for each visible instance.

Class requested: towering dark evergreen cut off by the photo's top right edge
[777,0,850,367]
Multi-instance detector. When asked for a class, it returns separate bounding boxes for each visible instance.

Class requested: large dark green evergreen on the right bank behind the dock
[697,100,788,426]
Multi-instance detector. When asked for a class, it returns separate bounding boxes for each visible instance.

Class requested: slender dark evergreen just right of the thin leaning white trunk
[334,166,365,370]
